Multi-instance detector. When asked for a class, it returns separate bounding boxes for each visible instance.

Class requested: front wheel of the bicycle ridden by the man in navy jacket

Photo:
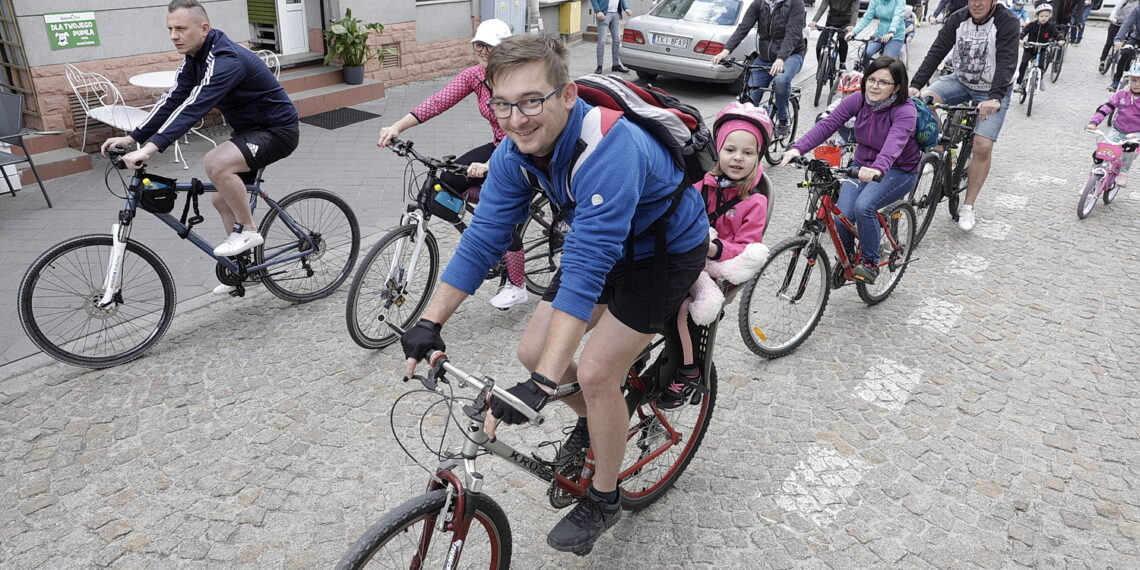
[17,235,177,368]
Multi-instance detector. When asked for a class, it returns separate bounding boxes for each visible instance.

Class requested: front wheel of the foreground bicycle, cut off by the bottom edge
[336,489,511,570]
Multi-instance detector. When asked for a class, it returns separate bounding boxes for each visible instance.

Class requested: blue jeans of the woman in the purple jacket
[836,169,919,263]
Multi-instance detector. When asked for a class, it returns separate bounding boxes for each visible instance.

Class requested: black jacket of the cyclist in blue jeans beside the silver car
[724,0,807,62]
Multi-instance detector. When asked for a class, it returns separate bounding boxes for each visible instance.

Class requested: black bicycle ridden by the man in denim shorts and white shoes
[907,97,978,246]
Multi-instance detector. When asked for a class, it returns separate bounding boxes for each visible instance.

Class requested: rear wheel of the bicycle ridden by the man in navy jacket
[253,188,360,303]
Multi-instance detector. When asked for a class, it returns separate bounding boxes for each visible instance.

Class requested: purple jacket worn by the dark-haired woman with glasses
[791,92,922,173]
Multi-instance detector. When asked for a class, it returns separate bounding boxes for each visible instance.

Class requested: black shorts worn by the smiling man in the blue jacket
[543,241,709,334]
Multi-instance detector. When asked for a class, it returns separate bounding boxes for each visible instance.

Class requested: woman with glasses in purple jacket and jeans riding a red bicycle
[781,56,922,284]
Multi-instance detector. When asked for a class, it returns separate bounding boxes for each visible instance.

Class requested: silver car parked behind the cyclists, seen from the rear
[621,0,756,92]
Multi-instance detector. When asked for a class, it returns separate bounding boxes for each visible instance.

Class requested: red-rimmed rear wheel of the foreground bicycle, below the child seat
[618,342,717,511]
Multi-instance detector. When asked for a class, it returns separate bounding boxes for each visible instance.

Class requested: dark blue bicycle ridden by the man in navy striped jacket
[17,147,360,368]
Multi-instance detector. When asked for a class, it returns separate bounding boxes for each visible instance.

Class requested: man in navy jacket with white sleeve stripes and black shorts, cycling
[103,0,299,285]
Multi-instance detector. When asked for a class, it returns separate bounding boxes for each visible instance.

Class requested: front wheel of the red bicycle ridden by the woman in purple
[736,236,831,358]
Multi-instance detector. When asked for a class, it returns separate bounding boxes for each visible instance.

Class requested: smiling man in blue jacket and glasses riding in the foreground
[400,34,708,554]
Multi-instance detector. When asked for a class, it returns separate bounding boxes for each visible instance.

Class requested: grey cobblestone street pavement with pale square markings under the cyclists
[0,26,1140,569]
